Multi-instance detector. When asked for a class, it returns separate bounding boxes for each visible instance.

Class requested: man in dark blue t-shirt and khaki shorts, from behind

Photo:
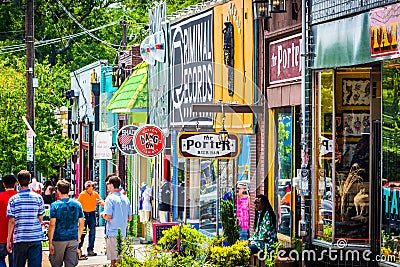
[49,180,85,267]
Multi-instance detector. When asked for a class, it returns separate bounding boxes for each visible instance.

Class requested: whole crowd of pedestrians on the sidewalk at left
[0,170,132,267]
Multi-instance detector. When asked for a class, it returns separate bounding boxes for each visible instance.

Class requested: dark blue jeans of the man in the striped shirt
[13,241,42,267]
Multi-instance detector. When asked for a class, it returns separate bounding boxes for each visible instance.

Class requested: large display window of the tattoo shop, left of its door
[313,68,373,245]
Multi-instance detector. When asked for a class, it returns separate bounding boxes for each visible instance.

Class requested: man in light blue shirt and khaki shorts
[101,176,132,267]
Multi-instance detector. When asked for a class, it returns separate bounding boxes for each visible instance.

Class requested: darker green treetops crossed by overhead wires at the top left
[0,0,201,71]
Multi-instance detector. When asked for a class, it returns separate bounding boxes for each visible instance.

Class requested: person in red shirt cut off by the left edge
[0,174,18,267]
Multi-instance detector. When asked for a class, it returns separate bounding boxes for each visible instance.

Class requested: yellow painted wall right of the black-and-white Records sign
[214,0,254,134]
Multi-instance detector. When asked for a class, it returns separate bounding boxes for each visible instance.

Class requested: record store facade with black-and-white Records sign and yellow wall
[149,1,255,235]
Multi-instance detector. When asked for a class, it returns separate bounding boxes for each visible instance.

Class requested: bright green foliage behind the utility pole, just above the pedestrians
[0,57,74,176]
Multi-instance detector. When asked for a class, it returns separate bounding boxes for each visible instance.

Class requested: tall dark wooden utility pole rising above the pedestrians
[25,0,36,178]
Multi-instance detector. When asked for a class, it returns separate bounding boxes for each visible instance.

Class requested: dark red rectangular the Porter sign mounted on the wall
[269,34,301,84]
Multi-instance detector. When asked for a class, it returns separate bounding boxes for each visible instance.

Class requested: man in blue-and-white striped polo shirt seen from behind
[7,170,44,267]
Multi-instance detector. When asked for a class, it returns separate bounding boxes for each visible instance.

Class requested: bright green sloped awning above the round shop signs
[107,62,147,113]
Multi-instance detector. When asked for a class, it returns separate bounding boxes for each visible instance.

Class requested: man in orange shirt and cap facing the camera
[78,181,103,259]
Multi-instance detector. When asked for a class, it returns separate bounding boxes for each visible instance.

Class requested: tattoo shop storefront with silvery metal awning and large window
[308,1,400,266]
